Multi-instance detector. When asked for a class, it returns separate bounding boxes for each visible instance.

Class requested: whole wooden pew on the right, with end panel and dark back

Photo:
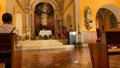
[88,31,120,68]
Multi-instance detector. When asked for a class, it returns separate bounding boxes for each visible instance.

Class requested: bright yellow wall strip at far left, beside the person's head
[0,0,6,25]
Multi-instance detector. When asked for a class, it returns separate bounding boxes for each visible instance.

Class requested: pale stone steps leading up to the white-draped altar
[18,40,74,50]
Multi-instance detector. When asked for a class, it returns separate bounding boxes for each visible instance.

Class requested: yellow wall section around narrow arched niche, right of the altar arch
[63,3,75,29]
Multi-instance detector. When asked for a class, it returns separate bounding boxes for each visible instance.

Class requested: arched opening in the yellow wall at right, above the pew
[96,8,119,40]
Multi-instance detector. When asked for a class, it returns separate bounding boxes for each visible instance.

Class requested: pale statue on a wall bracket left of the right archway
[85,7,93,30]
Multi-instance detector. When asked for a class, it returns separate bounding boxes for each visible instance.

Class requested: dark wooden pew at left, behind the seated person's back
[0,33,22,68]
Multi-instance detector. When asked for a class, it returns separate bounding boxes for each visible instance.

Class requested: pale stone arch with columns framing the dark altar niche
[30,0,59,39]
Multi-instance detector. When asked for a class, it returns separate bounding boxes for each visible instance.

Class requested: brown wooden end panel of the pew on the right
[88,43,109,68]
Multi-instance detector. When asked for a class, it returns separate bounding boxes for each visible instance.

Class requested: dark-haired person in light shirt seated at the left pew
[0,13,19,68]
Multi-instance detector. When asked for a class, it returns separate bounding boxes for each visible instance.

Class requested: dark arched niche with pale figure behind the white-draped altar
[34,2,55,35]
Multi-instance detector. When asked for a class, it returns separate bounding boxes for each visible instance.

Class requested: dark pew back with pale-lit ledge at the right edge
[105,31,120,55]
